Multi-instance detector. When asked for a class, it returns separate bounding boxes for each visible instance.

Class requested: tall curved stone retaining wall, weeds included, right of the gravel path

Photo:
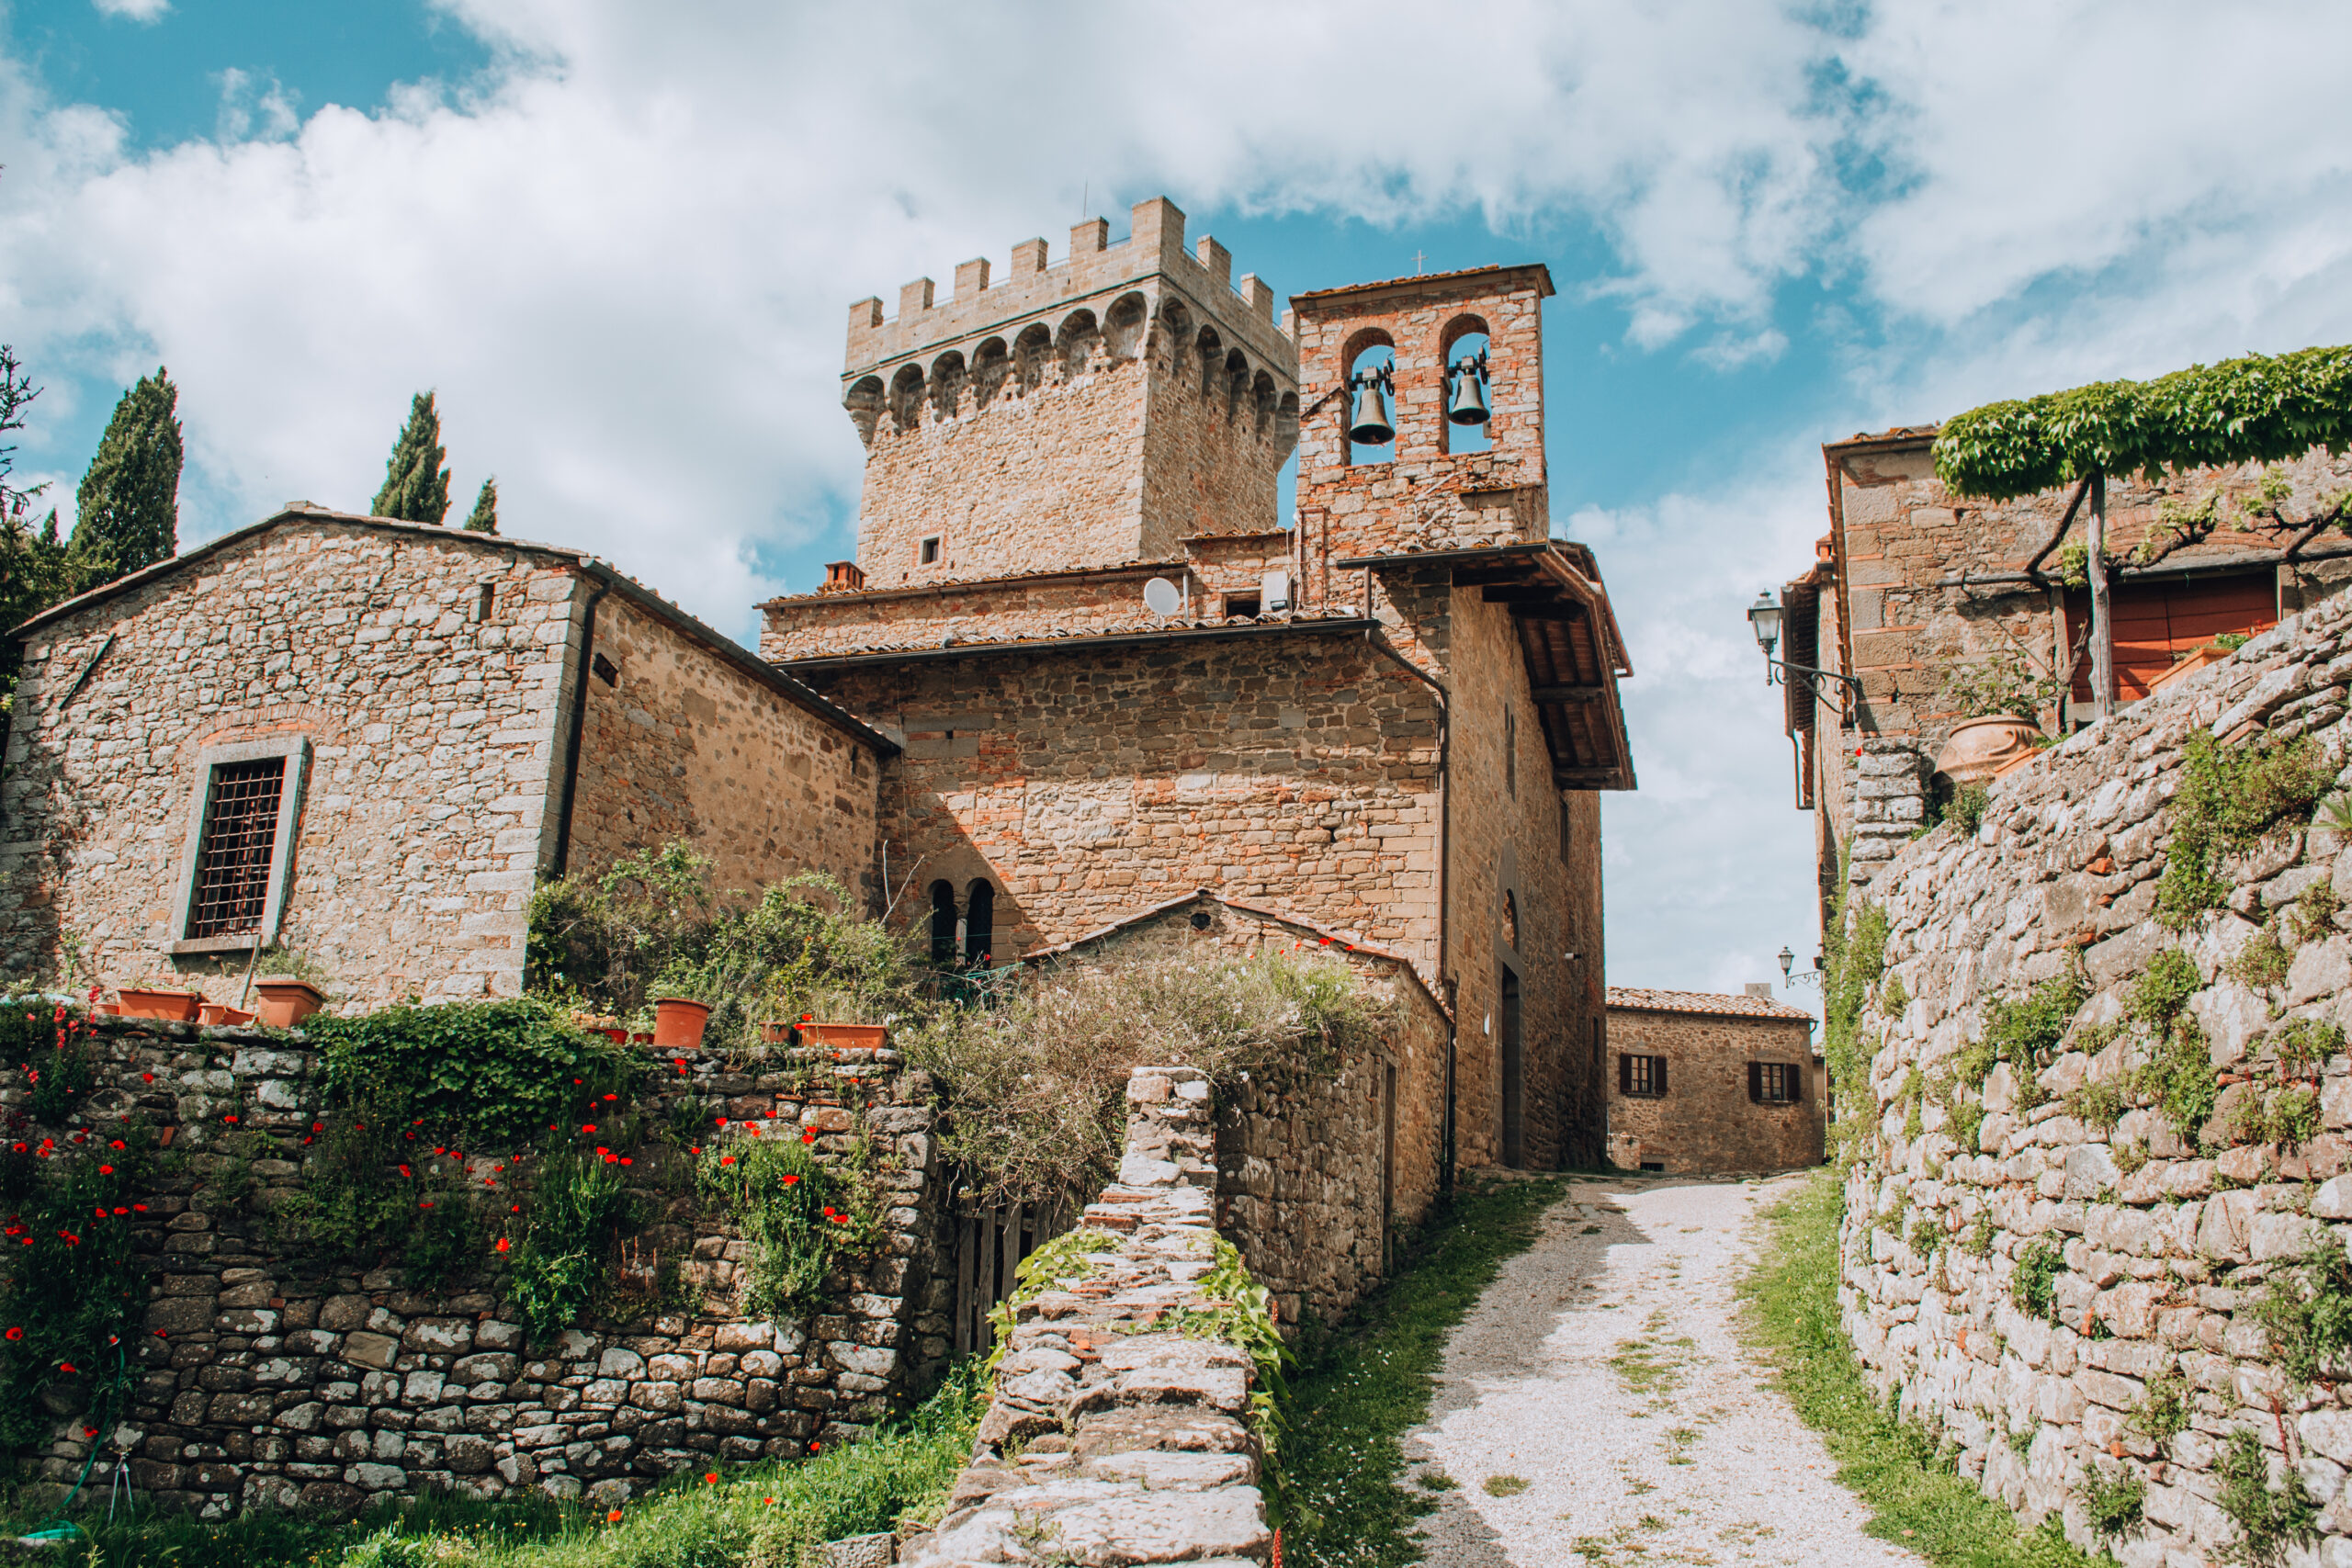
[1827,582,2352,1568]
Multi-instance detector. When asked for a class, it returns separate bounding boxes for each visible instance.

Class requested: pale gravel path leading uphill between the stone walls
[1407,1178,1922,1568]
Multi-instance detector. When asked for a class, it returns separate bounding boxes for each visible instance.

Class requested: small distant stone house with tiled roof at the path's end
[1609,983,1827,1176]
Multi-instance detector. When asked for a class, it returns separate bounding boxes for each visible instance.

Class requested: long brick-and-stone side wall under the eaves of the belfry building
[805,635,1437,962]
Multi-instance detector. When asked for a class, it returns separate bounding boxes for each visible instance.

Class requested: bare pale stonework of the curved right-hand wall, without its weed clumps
[1839,582,2352,1568]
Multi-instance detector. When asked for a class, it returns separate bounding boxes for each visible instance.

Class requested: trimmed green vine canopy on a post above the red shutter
[1936,345,2352,501]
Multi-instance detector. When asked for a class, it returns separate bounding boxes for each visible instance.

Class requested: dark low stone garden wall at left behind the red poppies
[0,1013,953,1517]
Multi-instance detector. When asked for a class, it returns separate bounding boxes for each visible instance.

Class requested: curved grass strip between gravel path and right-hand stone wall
[1740,1170,2105,1568]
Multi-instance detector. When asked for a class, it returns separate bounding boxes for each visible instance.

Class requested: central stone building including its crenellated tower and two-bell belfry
[762,200,1633,1184]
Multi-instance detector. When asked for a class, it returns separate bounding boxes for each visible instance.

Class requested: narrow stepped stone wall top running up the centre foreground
[900,1067,1275,1568]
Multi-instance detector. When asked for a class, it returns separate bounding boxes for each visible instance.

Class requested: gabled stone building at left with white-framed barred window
[0,503,896,1006]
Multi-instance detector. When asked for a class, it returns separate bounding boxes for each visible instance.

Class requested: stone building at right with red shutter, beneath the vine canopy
[1778,425,2352,919]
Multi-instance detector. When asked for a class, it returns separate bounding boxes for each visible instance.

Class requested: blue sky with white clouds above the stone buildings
[0,0,2352,1006]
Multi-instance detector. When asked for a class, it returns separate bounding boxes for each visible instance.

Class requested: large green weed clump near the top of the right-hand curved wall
[2157,728,2335,931]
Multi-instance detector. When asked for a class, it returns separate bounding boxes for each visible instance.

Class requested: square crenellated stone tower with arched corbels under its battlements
[842,197,1298,588]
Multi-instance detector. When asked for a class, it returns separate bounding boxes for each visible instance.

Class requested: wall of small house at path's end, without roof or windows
[1609,1006,1826,1176]
